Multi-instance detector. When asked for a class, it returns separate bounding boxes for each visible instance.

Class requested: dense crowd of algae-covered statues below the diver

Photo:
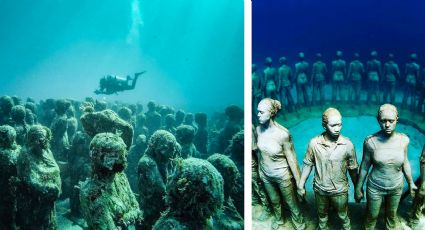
[0,96,244,230]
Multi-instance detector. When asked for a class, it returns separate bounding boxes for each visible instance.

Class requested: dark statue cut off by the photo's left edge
[0,125,21,229]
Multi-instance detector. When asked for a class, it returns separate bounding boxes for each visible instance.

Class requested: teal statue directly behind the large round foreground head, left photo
[176,125,199,159]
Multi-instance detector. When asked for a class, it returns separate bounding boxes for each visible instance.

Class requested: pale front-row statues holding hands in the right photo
[252,98,425,229]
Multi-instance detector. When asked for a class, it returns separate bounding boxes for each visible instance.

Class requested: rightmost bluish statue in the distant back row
[401,53,422,111]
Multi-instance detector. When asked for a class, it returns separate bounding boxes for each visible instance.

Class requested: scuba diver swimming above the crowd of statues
[94,71,146,95]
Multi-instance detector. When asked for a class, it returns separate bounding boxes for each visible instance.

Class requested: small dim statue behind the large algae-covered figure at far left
[10,105,30,146]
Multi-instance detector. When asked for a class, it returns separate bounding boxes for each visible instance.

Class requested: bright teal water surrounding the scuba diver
[0,0,243,112]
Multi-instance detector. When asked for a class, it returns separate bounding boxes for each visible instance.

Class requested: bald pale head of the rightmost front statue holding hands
[377,104,398,135]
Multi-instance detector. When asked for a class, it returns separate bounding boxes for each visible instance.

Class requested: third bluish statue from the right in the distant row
[366,51,381,104]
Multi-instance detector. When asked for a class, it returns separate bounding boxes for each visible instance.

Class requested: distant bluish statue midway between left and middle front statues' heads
[295,52,309,106]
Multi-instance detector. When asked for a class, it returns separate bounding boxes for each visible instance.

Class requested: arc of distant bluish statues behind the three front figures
[252,51,425,120]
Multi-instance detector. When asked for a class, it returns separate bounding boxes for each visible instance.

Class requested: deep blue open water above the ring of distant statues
[252,0,425,71]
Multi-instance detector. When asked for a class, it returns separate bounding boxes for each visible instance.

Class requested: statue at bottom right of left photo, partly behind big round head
[207,153,244,230]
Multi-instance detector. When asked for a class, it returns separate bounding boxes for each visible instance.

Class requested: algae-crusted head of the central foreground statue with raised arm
[90,133,127,172]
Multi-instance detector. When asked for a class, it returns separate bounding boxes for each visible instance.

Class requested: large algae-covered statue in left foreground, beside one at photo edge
[17,125,61,229]
